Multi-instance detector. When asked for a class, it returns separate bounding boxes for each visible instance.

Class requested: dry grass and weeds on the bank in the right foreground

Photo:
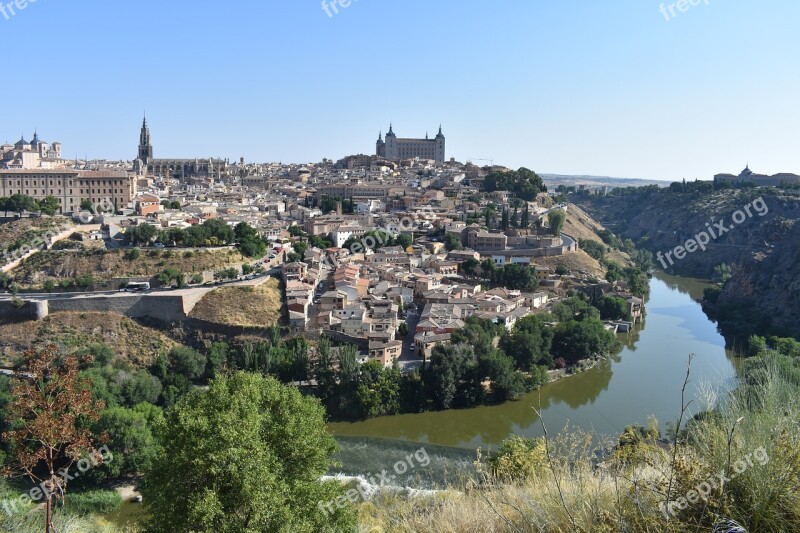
[361,358,800,533]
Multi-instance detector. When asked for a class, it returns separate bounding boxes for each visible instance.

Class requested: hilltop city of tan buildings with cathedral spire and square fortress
[0,119,656,367]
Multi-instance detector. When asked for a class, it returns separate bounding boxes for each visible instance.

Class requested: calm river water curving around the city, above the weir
[330,273,736,449]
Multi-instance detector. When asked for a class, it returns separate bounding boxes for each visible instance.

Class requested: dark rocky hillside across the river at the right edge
[573,188,800,336]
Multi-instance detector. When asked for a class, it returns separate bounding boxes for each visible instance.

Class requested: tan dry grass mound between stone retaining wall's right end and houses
[189,278,281,328]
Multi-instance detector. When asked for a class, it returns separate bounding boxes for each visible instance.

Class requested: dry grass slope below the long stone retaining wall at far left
[0,312,177,366]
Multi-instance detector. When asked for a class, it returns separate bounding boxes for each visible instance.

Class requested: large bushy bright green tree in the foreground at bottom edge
[141,373,357,533]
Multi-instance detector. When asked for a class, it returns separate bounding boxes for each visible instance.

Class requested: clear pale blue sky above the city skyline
[0,0,800,180]
